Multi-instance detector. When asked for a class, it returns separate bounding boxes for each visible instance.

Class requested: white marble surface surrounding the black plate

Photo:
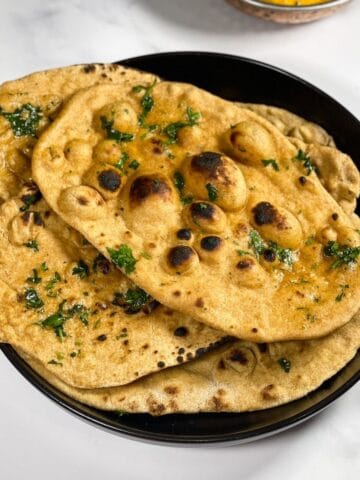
[0,0,360,480]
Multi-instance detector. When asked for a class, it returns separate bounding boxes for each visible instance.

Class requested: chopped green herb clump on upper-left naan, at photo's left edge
[0,103,43,137]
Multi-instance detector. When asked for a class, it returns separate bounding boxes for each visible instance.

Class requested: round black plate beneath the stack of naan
[1,52,360,445]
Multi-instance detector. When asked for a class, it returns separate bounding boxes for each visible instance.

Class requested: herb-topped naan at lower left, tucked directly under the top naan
[0,186,224,388]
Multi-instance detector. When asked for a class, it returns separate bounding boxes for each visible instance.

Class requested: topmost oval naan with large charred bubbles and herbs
[33,82,360,341]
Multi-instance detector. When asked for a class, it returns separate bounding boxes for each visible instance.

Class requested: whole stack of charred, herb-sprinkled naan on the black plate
[0,65,360,415]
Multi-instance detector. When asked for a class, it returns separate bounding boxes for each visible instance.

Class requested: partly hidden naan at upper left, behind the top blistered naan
[0,64,157,203]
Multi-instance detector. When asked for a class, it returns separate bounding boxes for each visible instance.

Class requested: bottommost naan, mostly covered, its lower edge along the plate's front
[15,314,360,415]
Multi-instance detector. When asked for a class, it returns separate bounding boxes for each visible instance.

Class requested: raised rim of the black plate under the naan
[0,51,360,446]
